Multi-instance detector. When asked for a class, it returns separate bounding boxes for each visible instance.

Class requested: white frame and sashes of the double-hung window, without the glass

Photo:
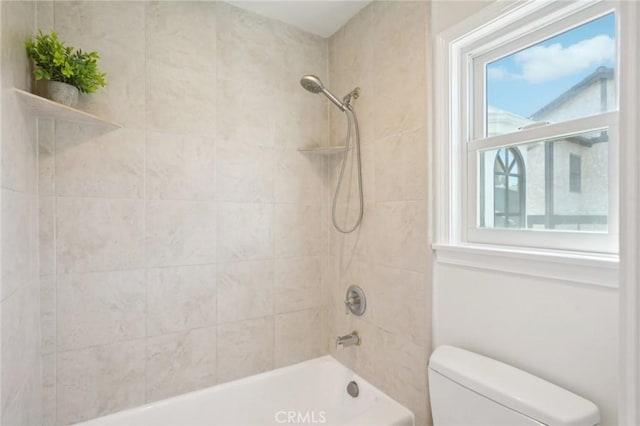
[435,1,620,256]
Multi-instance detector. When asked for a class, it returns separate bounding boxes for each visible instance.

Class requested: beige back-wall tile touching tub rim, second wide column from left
[147,327,216,402]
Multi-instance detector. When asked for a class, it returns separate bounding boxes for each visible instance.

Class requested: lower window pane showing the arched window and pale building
[478,130,609,232]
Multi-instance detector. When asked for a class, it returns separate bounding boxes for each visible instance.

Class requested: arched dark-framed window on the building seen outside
[493,148,526,228]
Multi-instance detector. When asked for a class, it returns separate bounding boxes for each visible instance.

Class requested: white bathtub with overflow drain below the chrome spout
[78,355,414,426]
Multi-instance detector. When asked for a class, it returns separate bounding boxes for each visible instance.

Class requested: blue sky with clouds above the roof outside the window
[487,13,616,117]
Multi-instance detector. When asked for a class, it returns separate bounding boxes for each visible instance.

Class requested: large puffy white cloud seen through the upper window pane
[489,35,615,83]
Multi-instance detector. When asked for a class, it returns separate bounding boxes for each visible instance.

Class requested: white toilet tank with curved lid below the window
[429,346,600,426]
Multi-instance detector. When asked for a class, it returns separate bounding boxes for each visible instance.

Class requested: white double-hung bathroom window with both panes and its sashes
[452,2,618,253]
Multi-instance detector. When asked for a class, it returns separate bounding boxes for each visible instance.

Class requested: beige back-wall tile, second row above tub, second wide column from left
[147,265,217,336]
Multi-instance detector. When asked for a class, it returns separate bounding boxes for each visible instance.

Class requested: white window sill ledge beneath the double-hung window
[432,244,620,288]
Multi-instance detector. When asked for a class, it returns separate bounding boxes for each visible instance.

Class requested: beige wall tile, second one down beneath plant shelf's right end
[56,198,144,273]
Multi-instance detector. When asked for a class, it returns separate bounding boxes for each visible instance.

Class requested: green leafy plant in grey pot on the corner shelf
[26,30,106,106]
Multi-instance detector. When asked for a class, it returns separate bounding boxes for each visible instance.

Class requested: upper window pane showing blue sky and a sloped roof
[485,13,617,136]
